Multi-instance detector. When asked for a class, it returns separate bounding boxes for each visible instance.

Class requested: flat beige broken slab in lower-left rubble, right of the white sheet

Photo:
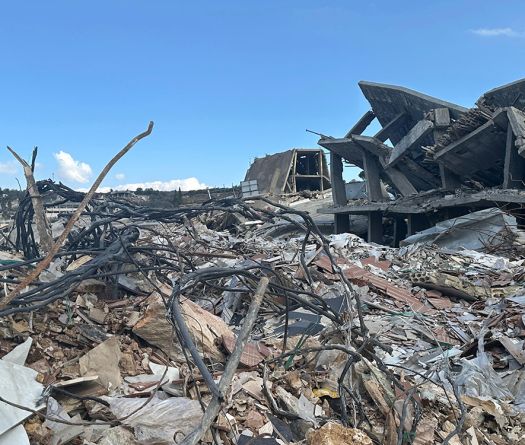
[79,337,122,389]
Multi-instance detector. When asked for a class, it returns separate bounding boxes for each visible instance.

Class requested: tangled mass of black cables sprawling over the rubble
[0,181,438,444]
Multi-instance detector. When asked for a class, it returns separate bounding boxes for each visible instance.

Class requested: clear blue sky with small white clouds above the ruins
[0,0,525,188]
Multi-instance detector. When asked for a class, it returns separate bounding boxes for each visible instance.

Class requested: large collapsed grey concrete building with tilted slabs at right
[318,79,525,245]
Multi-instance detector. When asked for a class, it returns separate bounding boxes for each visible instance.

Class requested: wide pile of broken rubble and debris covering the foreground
[0,181,525,445]
